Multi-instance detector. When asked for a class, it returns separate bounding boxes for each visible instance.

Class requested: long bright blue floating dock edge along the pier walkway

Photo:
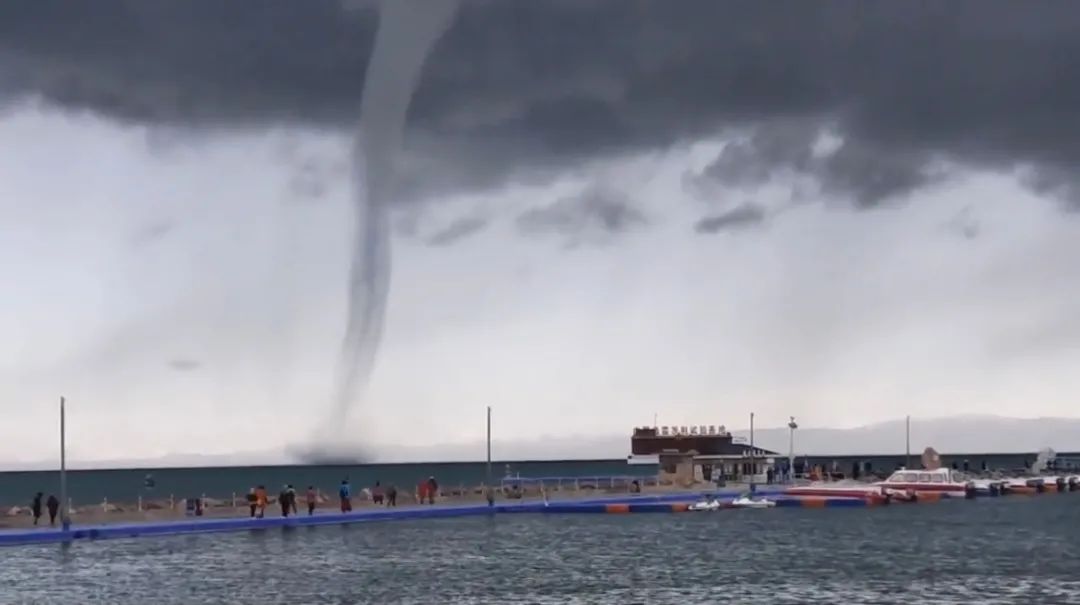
[0,490,812,547]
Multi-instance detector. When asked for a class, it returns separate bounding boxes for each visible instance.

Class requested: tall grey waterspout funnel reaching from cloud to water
[304,0,458,458]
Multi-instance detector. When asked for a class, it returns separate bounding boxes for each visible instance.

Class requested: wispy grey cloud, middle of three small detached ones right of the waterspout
[517,187,648,239]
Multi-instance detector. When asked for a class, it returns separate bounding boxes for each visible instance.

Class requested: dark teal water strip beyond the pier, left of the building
[0,460,656,507]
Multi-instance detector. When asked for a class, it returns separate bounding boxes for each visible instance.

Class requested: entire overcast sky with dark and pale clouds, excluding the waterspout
[0,0,1080,461]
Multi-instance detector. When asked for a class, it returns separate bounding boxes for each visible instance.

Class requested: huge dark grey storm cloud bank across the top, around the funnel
[0,0,1080,205]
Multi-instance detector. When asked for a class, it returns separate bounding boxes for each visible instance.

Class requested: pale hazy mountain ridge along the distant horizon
[0,416,1080,470]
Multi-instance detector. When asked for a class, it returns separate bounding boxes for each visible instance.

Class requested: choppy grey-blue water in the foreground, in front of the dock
[0,494,1080,605]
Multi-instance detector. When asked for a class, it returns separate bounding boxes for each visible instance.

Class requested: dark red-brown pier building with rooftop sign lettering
[626,425,779,485]
